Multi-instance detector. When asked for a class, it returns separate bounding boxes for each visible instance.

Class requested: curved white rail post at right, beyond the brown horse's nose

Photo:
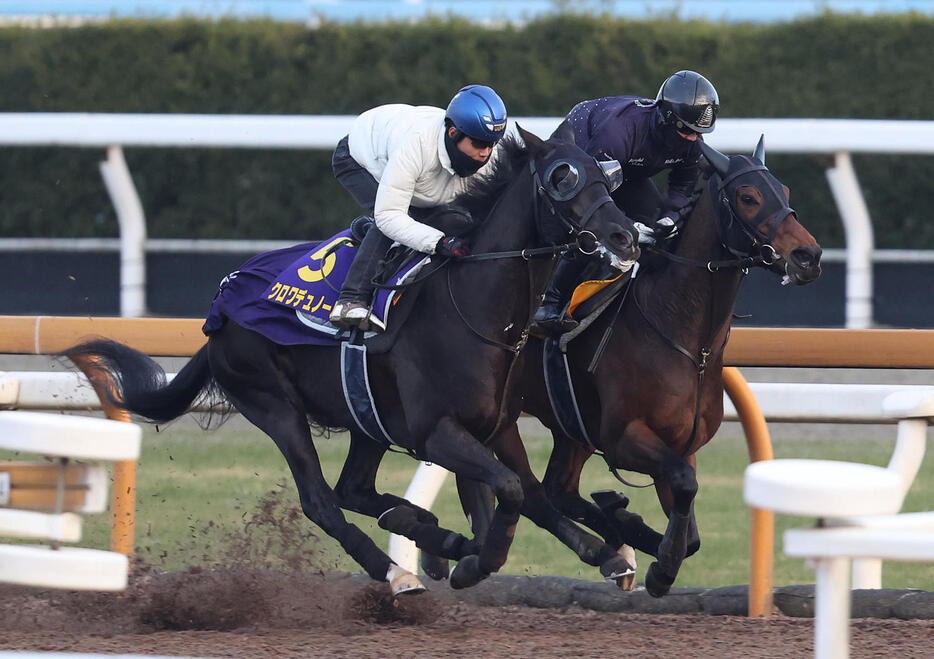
[827,151,874,329]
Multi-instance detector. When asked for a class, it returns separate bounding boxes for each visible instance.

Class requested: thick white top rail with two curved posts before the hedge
[0,112,934,329]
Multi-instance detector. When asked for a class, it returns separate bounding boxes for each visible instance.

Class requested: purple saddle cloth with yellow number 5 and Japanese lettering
[202,229,429,345]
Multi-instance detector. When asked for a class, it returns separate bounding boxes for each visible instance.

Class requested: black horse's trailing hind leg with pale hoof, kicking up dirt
[210,346,424,594]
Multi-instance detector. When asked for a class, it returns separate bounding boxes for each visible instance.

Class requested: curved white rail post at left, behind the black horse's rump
[100,146,146,318]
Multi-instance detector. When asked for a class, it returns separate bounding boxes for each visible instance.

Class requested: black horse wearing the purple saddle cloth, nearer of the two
[65,123,639,594]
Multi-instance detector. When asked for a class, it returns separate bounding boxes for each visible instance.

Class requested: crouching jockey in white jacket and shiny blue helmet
[330,85,506,330]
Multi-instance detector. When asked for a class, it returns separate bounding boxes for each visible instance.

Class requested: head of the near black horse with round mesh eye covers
[518,121,639,262]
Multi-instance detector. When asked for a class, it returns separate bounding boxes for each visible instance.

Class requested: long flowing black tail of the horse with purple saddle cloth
[62,339,213,423]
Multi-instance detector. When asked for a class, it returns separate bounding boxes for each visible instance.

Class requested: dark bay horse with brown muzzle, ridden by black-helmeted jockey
[458,140,821,596]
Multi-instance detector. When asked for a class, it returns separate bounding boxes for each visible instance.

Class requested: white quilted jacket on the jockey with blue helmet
[348,104,492,254]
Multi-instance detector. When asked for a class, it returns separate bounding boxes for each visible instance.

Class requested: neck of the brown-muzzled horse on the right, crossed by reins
[640,189,743,352]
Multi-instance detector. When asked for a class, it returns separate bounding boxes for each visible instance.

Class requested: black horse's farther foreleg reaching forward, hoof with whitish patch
[495,424,635,585]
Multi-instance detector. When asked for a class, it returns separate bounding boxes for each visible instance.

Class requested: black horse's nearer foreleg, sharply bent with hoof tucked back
[425,417,523,588]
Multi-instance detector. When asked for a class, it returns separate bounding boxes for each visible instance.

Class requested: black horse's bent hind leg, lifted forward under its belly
[335,431,476,580]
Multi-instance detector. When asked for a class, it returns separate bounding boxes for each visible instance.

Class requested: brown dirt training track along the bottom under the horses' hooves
[0,568,934,659]
